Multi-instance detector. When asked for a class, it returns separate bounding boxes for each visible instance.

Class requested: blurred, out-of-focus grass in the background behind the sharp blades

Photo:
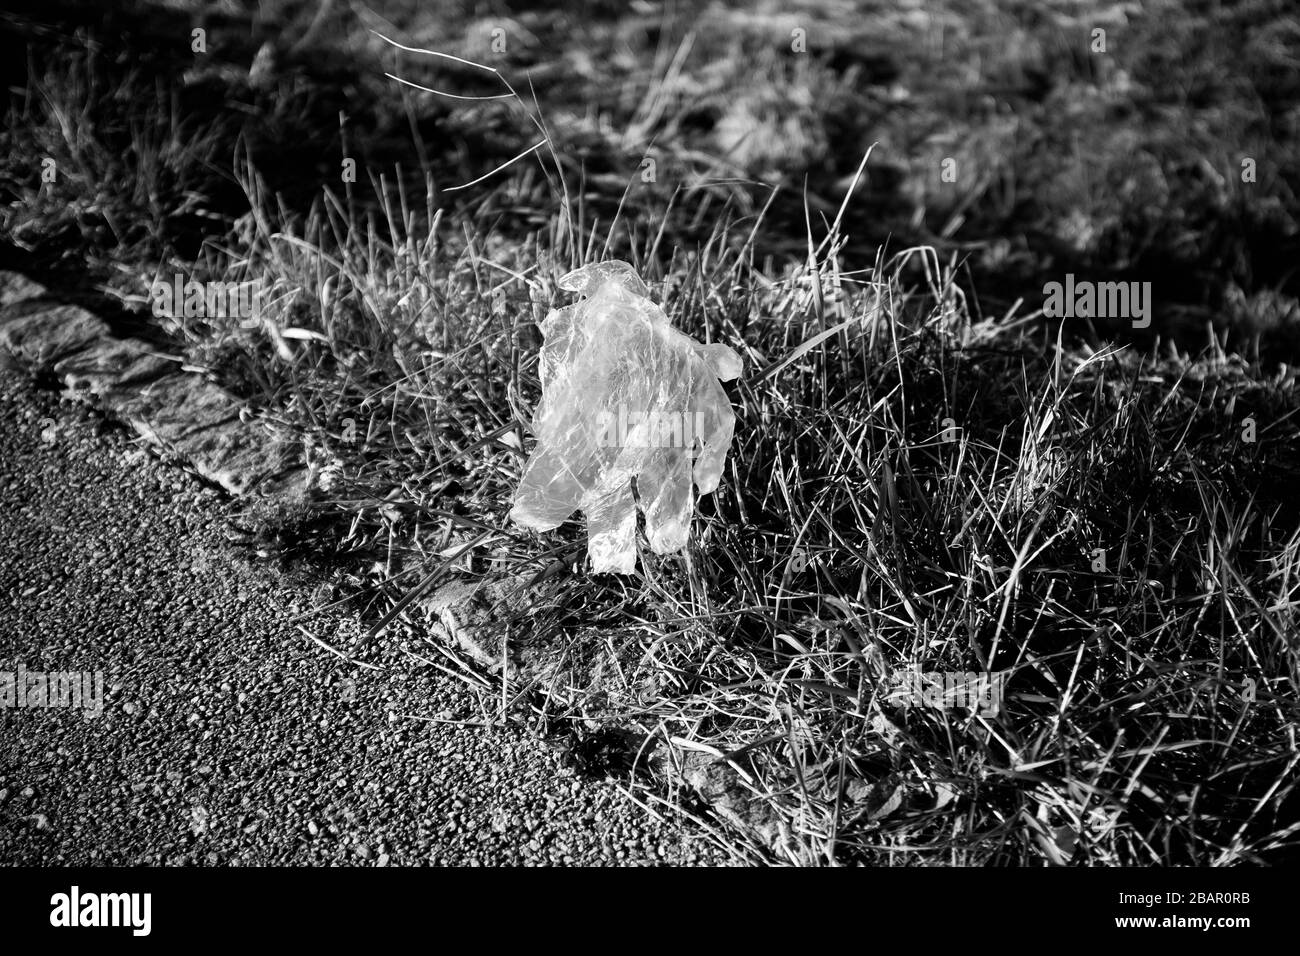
[10,0,1300,348]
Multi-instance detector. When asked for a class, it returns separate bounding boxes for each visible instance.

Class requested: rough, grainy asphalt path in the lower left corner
[0,371,719,865]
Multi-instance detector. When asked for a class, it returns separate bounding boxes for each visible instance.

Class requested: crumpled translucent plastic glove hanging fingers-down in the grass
[510,260,741,574]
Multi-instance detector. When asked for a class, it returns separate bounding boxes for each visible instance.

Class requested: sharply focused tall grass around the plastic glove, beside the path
[96,151,1300,864]
